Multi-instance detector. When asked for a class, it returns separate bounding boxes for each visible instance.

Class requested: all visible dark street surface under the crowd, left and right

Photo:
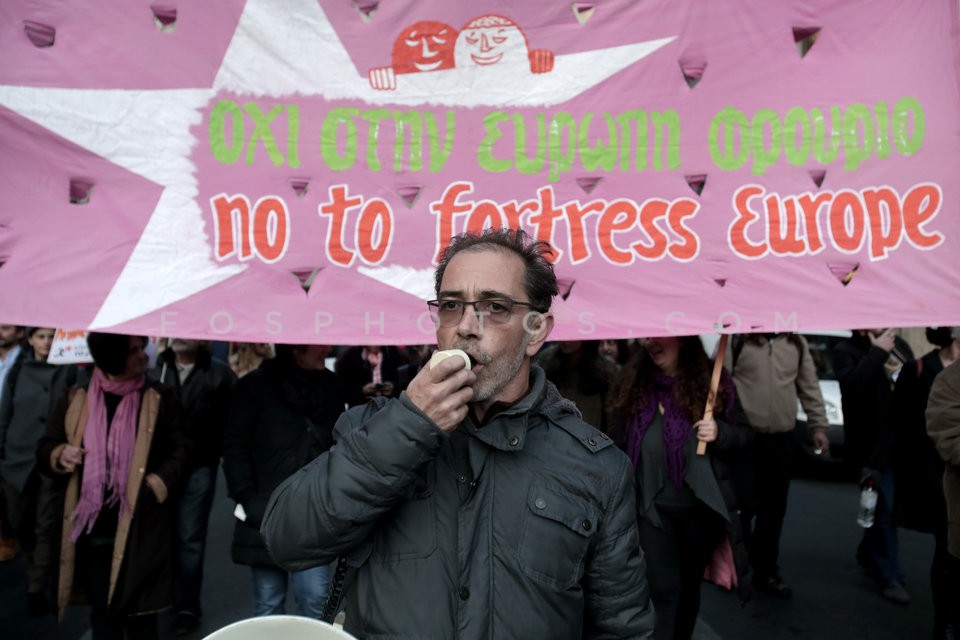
[0,470,933,640]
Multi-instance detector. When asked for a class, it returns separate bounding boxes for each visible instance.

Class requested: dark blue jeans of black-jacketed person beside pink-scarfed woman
[174,466,217,617]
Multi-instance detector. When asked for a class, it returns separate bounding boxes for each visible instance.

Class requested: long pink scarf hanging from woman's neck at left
[70,368,144,542]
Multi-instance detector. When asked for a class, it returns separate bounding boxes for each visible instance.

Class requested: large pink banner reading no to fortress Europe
[0,0,960,343]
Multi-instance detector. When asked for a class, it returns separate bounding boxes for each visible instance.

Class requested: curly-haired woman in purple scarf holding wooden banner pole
[611,336,752,640]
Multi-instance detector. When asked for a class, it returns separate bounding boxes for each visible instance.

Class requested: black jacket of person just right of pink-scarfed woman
[150,348,237,468]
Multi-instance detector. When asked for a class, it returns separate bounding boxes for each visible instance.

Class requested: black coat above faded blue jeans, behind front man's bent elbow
[223,359,344,567]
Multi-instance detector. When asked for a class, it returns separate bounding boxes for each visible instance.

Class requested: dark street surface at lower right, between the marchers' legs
[700,472,933,640]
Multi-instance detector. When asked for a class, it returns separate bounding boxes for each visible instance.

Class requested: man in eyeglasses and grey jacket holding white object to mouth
[261,229,654,640]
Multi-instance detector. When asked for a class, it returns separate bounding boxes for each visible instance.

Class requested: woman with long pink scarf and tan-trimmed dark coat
[37,333,188,640]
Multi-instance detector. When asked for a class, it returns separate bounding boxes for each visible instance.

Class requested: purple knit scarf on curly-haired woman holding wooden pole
[627,371,734,489]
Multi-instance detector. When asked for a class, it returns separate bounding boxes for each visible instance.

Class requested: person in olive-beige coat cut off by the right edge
[927,361,960,636]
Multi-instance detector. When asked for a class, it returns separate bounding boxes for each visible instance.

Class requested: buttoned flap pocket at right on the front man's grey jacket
[517,484,599,589]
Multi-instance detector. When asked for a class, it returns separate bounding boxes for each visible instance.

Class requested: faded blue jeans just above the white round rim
[250,565,331,620]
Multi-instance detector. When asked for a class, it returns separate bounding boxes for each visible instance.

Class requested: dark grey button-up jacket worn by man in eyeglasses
[263,367,653,640]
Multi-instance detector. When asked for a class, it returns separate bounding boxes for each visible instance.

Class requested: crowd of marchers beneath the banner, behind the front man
[0,325,960,639]
